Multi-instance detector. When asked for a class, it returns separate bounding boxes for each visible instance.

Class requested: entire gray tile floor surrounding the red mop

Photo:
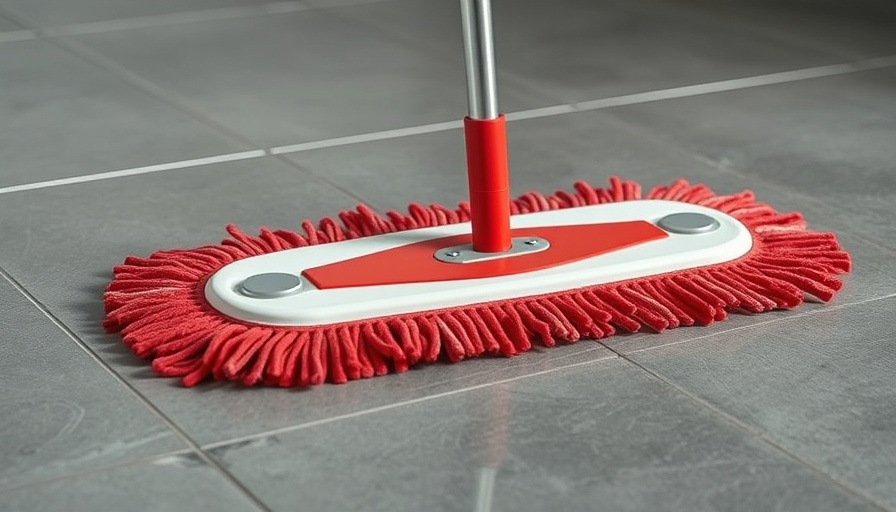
[0,0,896,512]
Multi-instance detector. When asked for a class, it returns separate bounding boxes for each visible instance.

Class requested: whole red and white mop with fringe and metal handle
[103,0,851,387]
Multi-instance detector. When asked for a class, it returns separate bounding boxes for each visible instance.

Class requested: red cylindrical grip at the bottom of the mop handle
[464,114,510,252]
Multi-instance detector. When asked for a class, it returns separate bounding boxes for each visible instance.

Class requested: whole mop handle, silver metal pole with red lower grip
[460,0,511,252]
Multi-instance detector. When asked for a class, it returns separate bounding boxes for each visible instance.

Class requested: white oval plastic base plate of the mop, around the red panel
[205,200,753,326]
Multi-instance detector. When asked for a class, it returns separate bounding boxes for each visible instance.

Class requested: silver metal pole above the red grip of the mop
[460,0,498,119]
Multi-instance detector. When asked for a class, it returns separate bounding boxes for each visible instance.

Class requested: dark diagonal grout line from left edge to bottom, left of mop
[0,267,272,512]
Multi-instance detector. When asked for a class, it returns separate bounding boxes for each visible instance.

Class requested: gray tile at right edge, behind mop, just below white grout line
[610,70,896,252]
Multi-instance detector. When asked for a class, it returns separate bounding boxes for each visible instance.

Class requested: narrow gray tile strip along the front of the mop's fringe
[144,340,616,447]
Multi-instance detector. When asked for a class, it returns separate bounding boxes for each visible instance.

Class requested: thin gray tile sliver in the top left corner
[0,0,262,27]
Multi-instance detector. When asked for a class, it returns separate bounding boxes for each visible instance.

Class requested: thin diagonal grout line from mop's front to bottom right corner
[604,345,894,512]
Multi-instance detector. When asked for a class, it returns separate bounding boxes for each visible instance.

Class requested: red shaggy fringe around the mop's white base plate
[103,177,851,387]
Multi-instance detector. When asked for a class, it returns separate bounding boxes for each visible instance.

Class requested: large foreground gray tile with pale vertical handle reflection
[212,360,872,512]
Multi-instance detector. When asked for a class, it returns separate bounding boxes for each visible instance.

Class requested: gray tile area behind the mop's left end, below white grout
[0,158,356,328]
